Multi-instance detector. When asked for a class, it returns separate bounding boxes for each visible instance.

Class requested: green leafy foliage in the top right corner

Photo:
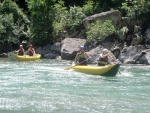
[122,0,150,21]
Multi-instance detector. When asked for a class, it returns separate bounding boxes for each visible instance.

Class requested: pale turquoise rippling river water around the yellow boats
[0,58,150,113]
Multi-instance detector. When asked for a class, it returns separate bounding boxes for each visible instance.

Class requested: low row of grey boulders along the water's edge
[36,38,150,65]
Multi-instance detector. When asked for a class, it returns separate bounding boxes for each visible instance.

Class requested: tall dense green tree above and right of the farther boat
[26,0,54,45]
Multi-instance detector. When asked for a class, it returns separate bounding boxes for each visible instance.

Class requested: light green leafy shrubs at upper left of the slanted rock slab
[53,0,95,36]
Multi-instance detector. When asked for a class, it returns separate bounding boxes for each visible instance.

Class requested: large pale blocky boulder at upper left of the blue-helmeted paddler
[61,38,86,60]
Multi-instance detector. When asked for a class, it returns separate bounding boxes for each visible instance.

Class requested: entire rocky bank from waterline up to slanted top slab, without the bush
[3,10,150,65]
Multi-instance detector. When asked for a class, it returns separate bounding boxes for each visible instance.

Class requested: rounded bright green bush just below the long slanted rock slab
[86,20,116,41]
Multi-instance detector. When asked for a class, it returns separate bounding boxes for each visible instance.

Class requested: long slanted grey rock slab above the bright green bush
[83,10,122,29]
